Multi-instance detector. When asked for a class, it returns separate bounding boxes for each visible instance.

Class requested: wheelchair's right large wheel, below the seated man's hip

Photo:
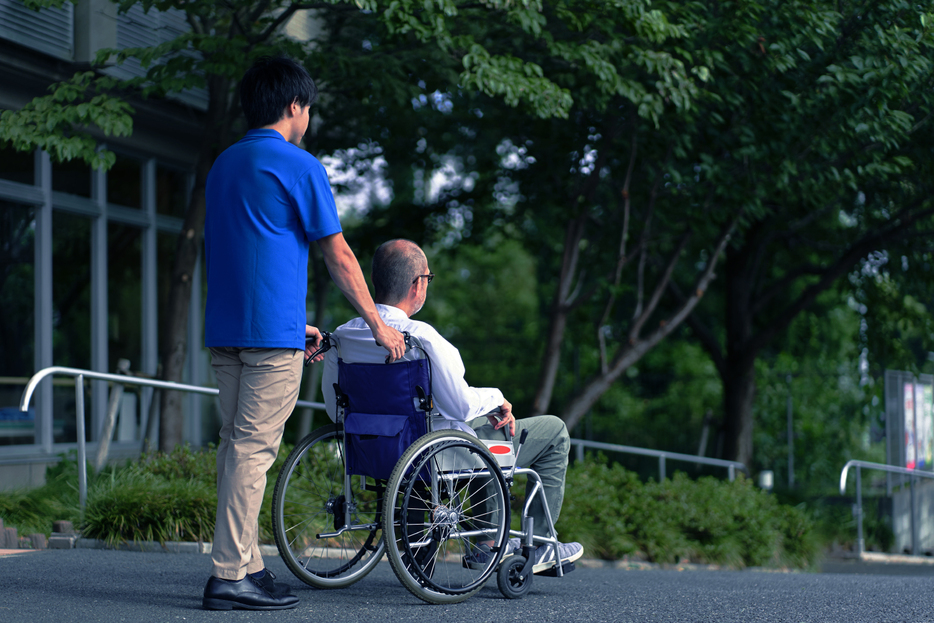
[383,431,509,604]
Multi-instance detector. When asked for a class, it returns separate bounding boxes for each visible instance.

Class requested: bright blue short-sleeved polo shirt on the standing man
[204,130,341,348]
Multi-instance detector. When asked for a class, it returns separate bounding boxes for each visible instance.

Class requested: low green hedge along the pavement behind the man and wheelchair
[0,447,820,568]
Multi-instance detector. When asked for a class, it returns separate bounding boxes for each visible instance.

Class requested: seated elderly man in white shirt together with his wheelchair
[273,240,583,603]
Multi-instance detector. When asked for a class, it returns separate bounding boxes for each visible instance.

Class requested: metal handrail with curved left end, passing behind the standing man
[19,366,325,513]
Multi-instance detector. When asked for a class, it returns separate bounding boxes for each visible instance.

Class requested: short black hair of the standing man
[240,56,318,130]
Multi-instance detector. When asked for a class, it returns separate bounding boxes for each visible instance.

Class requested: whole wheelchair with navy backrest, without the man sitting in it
[272,333,574,604]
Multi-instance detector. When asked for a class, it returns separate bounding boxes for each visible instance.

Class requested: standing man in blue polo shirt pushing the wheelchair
[202,57,405,610]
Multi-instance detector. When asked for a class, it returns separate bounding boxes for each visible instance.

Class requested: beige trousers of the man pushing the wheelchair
[210,348,303,580]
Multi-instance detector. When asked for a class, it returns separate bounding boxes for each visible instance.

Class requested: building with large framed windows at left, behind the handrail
[0,0,214,488]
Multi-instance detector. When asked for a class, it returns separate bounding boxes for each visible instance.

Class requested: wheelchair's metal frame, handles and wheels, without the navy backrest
[272,333,574,603]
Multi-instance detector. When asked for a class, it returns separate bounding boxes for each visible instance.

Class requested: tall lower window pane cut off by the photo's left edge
[0,200,35,445]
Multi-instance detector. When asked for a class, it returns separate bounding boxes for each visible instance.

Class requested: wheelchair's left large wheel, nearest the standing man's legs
[272,424,385,588]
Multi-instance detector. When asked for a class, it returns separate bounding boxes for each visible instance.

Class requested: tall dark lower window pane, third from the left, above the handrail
[107,223,142,372]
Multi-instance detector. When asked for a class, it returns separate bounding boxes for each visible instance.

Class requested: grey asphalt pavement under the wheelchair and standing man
[0,549,934,623]
